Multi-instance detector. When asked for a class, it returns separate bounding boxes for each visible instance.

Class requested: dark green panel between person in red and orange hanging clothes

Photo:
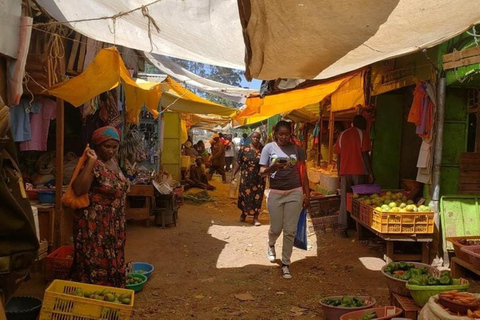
[372,93,403,189]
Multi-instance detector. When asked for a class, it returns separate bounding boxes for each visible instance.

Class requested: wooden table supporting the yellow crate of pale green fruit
[350,214,433,264]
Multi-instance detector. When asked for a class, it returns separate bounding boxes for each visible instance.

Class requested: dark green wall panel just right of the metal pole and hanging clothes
[440,88,468,195]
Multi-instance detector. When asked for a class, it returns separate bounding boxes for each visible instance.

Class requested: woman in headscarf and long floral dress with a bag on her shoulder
[72,127,129,287]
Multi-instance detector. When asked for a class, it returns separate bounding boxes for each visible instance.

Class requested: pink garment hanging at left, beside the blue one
[20,97,57,151]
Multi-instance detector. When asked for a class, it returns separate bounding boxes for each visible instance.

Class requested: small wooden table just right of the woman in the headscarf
[125,185,155,227]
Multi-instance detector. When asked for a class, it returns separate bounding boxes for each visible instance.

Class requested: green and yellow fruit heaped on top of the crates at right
[353,191,431,212]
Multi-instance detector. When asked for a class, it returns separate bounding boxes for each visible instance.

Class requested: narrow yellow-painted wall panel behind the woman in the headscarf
[162,112,182,181]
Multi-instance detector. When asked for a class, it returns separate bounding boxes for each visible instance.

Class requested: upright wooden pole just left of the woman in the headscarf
[53,98,65,248]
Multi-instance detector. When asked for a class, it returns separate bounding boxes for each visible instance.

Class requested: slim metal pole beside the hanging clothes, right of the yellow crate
[430,76,449,265]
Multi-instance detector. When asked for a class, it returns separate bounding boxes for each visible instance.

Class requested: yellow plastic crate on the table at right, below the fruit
[371,209,434,234]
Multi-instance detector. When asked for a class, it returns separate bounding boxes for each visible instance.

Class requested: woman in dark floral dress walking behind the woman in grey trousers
[233,132,265,226]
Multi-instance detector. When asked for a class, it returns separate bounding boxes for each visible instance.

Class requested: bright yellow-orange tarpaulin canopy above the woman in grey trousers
[235,70,365,125]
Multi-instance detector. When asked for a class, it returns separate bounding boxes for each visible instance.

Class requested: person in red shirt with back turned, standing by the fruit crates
[335,115,374,237]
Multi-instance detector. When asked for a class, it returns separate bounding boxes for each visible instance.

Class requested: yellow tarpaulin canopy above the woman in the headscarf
[48,47,236,123]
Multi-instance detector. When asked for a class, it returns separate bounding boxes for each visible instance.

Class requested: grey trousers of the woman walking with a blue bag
[267,191,303,265]
